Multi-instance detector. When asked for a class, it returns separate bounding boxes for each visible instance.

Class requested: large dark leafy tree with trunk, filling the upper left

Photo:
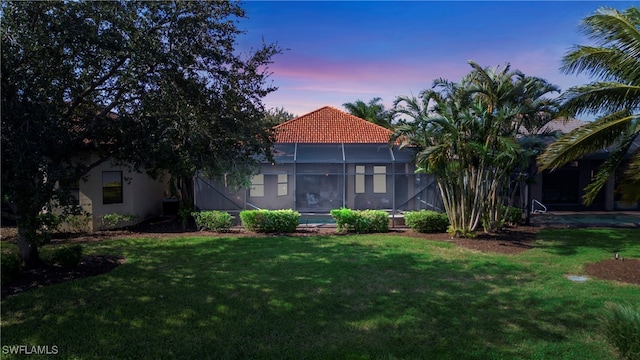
[1,1,280,266]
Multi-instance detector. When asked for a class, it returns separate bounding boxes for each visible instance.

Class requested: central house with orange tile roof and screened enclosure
[195,106,442,213]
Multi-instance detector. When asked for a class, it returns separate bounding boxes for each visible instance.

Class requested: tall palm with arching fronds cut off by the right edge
[538,7,640,205]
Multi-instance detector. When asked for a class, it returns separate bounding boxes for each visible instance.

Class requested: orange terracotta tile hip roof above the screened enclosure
[274,106,391,144]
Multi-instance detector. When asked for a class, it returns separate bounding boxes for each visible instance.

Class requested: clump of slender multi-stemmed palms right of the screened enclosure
[392,62,557,236]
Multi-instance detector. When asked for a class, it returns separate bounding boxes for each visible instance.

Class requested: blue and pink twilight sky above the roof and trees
[238,1,637,115]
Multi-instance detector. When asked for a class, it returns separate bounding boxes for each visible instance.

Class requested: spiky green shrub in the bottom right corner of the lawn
[600,303,640,360]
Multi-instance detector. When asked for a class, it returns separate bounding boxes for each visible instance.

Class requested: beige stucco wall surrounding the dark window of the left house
[78,158,169,231]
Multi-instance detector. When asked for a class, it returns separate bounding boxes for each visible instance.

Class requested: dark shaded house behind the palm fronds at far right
[531,119,640,211]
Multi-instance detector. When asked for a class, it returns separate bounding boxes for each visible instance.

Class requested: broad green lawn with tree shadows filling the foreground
[1,229,640,359]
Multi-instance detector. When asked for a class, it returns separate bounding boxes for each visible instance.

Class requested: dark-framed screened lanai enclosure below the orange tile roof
[195,143,442,214]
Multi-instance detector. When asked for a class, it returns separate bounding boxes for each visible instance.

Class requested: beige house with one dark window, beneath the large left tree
[66,153,169,232]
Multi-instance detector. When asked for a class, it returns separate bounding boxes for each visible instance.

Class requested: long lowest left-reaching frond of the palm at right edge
[538,111,637,170]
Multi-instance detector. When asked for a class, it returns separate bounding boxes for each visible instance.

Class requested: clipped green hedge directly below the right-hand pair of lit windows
[331,208,389,234]
